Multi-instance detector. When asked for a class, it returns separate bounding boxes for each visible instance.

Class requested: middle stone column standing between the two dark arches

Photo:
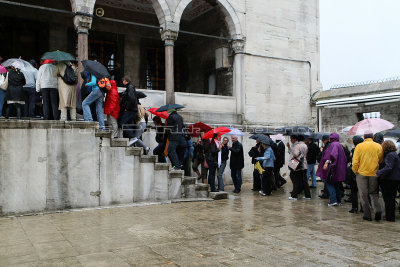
[161,30,178,104]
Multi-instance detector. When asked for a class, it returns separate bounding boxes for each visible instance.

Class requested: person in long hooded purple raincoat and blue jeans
[317,133,347,207]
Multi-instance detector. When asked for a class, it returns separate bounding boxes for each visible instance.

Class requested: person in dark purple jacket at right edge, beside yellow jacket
[376,141,400,222]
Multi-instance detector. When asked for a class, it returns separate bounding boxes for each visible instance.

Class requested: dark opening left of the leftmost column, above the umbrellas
[0,0,74,62]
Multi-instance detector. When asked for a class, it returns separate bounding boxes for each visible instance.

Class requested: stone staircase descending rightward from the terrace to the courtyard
[95,131,212,205]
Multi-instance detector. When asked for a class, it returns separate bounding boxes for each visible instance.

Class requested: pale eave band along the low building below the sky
[316,92,400,108]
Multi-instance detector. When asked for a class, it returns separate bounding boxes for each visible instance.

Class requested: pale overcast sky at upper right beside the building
[320,0,400,90]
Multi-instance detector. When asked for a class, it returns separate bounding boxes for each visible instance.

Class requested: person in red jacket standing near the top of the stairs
[104,80,120,138]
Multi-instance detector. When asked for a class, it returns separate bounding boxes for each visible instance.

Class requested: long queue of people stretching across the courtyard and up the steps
[0,60,400,221]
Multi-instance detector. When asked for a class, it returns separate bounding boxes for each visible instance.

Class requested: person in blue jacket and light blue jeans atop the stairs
[82,74,105,130]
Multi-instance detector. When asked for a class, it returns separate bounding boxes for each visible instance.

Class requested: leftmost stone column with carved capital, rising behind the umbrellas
[74,15,92,83]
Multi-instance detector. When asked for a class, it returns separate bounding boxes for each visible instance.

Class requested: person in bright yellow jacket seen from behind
[352,132,383,221]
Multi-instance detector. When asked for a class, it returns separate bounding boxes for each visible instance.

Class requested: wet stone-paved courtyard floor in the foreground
[0,184,400,267]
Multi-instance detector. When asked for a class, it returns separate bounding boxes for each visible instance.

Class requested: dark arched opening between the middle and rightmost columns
[175,0,233,96]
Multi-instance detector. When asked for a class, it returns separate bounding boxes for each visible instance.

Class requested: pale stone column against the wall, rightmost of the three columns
[232,40,246,116]
